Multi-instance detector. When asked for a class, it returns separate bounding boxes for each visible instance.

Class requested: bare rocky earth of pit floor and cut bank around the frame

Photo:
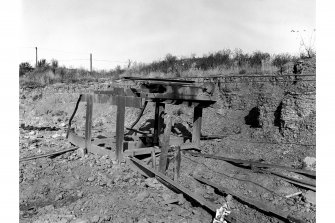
[20,58,316,222]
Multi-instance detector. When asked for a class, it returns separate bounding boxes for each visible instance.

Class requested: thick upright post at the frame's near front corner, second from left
[115,95,126,161]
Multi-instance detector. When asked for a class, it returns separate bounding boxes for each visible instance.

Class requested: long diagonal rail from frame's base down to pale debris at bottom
[130,157,242,222]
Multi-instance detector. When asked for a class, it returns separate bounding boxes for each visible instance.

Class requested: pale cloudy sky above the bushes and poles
[19,0,316,69]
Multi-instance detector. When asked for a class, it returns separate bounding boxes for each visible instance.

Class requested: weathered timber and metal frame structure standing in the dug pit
[67,77,216,161]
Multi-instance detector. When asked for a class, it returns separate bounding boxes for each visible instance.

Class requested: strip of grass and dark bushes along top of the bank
[19,49,315,85]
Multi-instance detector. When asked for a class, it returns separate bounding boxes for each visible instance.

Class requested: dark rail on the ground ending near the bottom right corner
[193,176,304,222]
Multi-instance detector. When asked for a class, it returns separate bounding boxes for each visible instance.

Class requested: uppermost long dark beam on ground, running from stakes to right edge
[187,151,316,177]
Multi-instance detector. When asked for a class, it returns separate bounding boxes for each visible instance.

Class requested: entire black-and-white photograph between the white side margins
[11,0,334,223]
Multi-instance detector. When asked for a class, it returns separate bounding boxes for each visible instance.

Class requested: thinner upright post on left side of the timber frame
[82,95,93,155]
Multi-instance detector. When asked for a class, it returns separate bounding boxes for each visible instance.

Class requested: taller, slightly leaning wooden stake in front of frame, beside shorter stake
[159,116,172,174]
